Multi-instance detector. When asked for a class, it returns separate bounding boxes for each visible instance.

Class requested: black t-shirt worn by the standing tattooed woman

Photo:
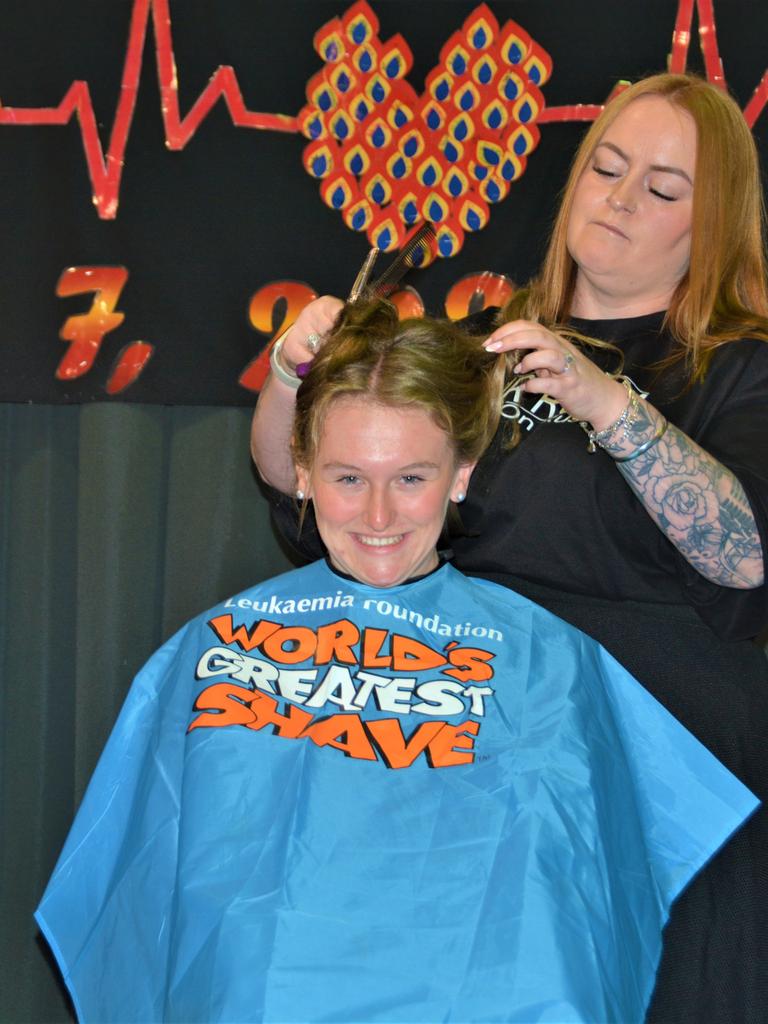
[268,310,768,640]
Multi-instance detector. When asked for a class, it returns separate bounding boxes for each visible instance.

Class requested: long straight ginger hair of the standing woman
[502,74,768,380]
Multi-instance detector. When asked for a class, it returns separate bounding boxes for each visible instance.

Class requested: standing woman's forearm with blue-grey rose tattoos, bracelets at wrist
[605,400,764,590]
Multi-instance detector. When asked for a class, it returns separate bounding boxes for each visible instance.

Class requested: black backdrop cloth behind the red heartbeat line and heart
[0,0,768,406]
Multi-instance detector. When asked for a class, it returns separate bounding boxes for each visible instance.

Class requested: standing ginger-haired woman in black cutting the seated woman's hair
[252,75,768,1024]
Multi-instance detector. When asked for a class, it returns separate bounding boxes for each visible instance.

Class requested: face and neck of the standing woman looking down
[567,96,696,316]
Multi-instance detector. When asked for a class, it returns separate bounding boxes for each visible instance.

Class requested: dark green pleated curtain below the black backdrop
[0,404,290,1024]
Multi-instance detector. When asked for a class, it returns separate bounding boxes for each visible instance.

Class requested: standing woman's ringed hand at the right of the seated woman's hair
[483,321,627,430]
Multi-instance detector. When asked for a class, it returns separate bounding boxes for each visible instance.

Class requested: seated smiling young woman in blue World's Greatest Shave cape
[37,302,756,1022]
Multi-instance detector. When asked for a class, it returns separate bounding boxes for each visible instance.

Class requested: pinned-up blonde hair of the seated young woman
[292,300,505,469]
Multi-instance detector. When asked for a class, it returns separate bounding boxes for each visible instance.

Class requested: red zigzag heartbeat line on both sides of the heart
[0,0,768,220]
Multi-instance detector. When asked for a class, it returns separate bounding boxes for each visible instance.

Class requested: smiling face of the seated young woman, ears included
[296,398,472,587]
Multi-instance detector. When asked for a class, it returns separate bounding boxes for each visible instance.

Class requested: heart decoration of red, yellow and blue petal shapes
[298,0,552,262]
